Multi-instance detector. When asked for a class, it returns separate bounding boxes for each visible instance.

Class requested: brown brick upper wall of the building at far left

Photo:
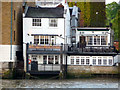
[0,2,35,45]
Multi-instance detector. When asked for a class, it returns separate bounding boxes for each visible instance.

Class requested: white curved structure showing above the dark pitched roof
[36,0,64,7]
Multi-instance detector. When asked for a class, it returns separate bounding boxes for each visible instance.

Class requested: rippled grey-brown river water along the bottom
[1,78,119,88]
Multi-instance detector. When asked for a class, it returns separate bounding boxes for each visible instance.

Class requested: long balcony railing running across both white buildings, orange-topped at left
[28,44,116,53]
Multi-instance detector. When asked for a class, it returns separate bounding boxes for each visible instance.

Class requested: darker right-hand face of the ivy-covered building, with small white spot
[90,2,106,27]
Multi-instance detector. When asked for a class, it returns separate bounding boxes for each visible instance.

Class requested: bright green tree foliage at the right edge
[106,2,120,40]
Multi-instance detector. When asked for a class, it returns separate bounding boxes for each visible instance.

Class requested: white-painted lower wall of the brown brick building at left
[0,45,21,62]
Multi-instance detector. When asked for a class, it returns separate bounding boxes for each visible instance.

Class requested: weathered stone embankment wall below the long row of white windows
[67,66,118,76]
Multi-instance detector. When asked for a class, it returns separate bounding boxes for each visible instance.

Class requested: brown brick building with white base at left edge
[0,1,22,68]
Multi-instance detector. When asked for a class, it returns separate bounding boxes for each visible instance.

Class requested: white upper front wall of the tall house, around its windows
[23,18,65,44]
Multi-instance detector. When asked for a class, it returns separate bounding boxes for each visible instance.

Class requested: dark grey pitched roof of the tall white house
[25,7,64,18]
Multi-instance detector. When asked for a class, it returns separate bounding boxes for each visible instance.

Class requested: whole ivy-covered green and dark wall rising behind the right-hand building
[69,2,106,27]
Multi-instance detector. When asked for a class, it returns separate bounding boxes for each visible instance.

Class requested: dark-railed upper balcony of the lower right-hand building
[65,45,117,54]
